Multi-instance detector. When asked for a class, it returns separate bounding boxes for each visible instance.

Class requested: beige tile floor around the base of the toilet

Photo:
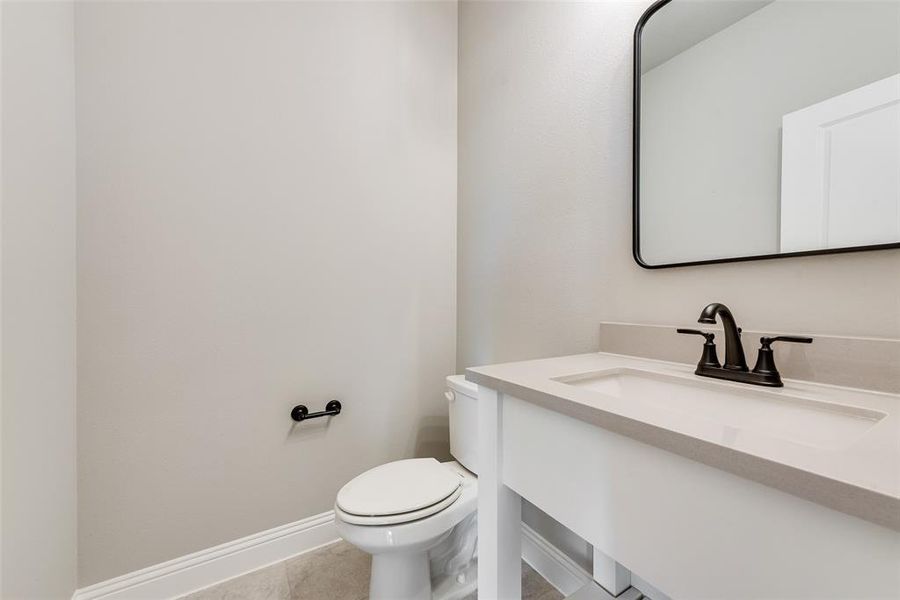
[179,542,563,600]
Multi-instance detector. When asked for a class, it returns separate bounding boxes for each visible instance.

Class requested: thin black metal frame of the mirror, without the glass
[632,0,900,269]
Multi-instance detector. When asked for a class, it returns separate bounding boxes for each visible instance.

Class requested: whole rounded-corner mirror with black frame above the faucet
[634,0,900,268]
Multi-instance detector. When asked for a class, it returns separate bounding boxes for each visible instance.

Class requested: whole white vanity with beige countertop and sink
[466,352,900,600]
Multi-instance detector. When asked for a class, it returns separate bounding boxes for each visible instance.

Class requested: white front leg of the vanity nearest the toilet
[478,386,522,600]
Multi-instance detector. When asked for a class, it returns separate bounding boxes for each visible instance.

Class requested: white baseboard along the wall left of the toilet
[72,511,339,600]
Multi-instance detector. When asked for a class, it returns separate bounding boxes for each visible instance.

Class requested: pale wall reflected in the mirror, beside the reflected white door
[641,0,900,264]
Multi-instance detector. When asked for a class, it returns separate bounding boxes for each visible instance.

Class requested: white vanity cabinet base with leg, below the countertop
[470,359,900,600]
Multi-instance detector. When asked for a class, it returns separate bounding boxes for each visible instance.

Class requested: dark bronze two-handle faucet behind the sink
[677,302,812,387]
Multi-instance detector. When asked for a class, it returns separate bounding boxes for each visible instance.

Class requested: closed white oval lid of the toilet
[337,458,462,517]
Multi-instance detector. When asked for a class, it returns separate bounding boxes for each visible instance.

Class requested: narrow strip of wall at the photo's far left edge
[0,2,76,600]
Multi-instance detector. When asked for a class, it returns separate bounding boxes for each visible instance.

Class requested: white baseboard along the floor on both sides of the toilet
[72,511,591,600]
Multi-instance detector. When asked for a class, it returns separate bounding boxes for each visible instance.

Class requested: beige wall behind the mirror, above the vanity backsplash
[457,2,900,584]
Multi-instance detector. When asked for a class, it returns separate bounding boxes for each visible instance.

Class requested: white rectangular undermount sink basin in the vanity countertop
[552,368,887,448]
